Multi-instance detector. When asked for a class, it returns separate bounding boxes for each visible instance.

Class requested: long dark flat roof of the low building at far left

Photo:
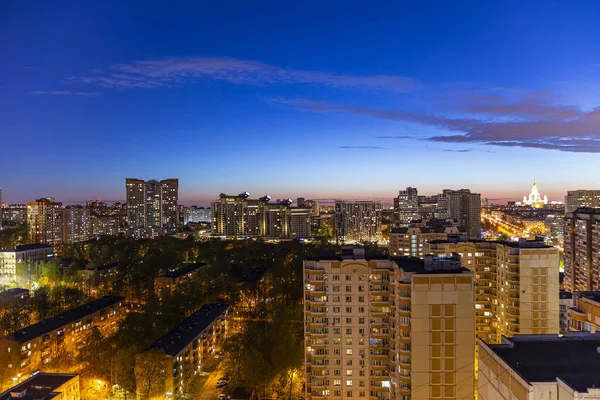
[10,295,125,343]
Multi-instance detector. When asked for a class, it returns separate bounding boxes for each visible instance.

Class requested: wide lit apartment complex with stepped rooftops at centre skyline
[211,192,311,239]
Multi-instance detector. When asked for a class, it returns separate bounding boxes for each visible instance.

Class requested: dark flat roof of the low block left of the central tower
[146,302,229,356]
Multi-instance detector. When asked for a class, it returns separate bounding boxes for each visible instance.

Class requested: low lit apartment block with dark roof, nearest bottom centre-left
[136,303,229,396]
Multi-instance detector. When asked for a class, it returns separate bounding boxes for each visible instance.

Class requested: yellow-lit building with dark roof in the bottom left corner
[0,372,80,400]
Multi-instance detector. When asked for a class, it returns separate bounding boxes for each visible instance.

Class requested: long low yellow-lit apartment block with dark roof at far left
[9,295,126,377]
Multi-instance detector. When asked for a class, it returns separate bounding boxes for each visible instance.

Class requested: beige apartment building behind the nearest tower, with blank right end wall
[425,236,560,343]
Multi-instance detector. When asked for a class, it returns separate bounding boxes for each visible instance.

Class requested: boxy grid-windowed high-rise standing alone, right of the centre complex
[335,200,381,242]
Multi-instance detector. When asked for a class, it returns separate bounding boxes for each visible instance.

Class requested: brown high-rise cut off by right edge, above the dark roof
[564,208,600,292]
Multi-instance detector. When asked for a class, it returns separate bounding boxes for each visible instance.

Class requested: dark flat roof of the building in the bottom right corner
[487,334,600,393]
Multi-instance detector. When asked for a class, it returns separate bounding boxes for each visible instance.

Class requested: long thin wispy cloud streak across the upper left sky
[67,57,419,92]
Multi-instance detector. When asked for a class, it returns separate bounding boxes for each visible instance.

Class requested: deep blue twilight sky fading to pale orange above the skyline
[0,1,600,204]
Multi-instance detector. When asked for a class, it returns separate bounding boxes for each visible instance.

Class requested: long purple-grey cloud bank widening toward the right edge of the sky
[270,98,600,153]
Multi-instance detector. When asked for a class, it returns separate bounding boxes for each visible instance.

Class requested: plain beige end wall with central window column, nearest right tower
[411,273,475,400]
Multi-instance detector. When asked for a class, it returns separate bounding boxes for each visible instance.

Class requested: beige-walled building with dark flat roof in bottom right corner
[478,334,600,400]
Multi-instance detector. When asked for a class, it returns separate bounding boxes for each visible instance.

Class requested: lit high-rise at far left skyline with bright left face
[27,197,63,249]
